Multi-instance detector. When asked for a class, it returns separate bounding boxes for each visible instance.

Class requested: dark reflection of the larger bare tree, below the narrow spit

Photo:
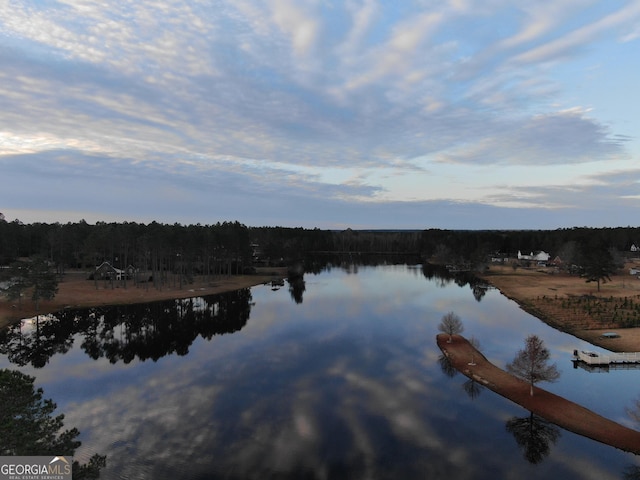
[506,412,561,464]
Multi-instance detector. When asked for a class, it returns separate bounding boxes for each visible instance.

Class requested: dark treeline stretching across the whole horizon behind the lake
[0,218,640,273]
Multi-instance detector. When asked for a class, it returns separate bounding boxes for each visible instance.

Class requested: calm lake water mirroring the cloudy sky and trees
[0,265,640,480]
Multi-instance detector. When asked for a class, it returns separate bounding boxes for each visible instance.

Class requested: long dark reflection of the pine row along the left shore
[0,288,252,368]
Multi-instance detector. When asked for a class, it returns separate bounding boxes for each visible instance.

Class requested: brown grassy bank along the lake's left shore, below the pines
[0,267,287,330]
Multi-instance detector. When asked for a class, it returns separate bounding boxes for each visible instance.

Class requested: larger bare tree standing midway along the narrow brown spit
[507,335,560,396]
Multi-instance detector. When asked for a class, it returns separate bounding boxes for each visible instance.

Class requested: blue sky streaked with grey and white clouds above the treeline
[0,0,640,229]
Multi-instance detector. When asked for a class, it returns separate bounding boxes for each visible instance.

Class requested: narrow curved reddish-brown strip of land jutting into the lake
[436,333,640,455]
